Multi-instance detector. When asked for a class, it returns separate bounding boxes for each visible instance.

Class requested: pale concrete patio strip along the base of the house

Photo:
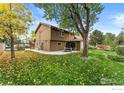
[26,49,79,55]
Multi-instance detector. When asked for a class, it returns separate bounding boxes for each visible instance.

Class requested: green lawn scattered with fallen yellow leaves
[0,50,124,85]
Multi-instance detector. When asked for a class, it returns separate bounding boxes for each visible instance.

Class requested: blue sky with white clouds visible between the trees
[27,3,124,35]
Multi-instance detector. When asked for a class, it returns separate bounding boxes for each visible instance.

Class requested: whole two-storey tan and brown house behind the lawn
[35,23,83,51]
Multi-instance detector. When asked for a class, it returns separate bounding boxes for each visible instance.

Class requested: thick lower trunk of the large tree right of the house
[82,34,88,58]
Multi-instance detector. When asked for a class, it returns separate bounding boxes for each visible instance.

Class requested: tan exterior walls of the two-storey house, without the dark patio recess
[35,25,81,51]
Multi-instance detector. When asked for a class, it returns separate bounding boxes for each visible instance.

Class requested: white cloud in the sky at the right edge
[112,13,124,26]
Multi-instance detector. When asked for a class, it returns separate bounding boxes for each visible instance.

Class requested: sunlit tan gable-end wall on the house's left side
[35,25,51,51]
